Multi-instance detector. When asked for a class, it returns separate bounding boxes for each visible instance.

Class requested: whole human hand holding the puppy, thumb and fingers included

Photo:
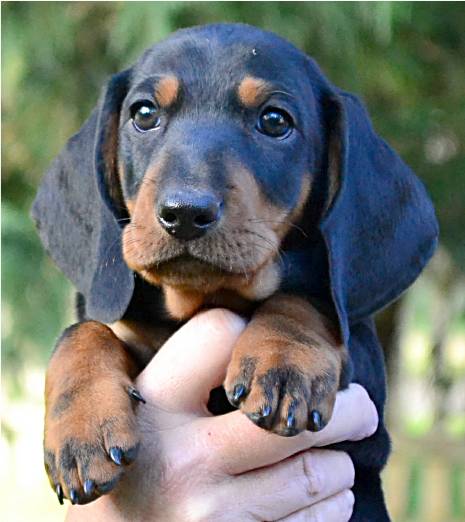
[67,310,378,522]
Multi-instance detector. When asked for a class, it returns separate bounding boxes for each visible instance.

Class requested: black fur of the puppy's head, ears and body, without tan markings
[33,25,438,522]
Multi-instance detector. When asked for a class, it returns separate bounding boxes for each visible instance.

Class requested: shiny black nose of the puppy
[158,192,222,241]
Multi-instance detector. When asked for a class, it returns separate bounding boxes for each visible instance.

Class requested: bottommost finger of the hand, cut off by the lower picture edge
[279,490,354,522]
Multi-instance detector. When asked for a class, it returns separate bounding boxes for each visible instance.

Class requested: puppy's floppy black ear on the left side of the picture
[32,70,134,323]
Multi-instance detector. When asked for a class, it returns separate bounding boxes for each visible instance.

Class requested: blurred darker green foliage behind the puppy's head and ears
[2,2,465,384]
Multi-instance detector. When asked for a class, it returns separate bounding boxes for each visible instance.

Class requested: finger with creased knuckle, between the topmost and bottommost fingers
[229,450,355,520]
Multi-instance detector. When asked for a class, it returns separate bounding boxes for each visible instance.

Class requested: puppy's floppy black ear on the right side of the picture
[320,91,438,339]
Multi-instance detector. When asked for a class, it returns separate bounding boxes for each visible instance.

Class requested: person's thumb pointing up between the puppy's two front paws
[137,309,246,413]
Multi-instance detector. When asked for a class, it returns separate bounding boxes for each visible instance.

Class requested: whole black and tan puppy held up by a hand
[33,25,437,522]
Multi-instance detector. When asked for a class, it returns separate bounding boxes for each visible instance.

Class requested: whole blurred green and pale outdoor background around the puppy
[0,2,465,522]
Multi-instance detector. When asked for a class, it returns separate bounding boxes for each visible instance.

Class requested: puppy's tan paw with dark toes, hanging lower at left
[44,377,143,504]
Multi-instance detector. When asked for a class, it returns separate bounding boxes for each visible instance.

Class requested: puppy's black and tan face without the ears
[118,28,318,316]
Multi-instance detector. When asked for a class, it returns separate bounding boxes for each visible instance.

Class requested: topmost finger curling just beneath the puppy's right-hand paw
[204,384,378,475]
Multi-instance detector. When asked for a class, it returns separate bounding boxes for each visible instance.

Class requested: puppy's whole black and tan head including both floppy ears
[33,24,437,329]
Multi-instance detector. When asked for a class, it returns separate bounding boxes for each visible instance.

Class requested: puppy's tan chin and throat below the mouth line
[132,258,281,319]
